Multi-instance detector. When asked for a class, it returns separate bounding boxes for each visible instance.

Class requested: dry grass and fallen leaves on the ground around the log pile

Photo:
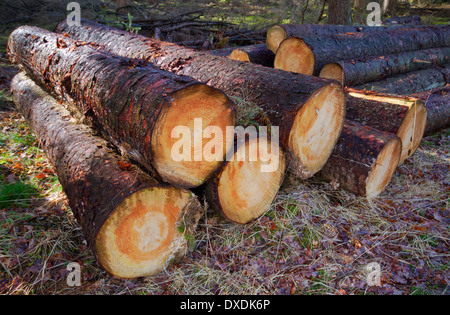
[0,0,450,295]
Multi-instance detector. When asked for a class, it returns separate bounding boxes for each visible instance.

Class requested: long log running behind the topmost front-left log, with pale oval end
[56,20,345,178]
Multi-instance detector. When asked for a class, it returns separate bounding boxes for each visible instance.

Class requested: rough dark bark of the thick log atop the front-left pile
[8,26,234,188]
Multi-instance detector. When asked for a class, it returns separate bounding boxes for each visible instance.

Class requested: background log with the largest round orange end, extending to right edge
[274,26,450,75]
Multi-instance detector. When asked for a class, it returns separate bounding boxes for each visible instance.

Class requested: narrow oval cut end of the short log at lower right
[366,138,402,199]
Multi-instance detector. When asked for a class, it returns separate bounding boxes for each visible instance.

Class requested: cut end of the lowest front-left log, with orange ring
[96,187,201,279]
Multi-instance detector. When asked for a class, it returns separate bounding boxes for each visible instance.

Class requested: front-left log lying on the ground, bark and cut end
[11,73,202,278]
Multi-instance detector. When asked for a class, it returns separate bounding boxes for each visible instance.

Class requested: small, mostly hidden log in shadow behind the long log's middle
[210,44,275,67]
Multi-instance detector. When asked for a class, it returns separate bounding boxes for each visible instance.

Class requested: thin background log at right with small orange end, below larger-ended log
[319,47,450,86]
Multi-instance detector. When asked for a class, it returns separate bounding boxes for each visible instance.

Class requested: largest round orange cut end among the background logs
[274,37,315,75]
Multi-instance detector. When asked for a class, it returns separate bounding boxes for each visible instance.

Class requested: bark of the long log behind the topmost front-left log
[56,20,345,178]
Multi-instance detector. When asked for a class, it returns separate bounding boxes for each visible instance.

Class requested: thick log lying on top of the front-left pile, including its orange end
[8,27,235,188]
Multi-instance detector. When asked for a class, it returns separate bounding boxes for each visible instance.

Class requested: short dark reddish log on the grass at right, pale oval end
[320,121,402,199]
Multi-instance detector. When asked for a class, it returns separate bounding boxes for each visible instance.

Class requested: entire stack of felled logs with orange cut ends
[8,20,450,278]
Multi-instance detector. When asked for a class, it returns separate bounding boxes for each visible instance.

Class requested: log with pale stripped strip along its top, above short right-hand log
[346,89,427,164]
